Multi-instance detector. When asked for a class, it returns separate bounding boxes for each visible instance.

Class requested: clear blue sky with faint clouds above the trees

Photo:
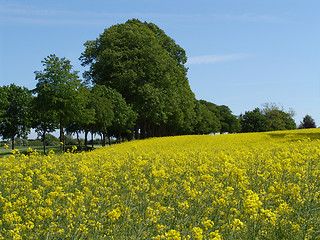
[0,0,320,125]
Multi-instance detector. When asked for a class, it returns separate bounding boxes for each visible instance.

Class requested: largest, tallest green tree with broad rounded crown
[80,19,194,138]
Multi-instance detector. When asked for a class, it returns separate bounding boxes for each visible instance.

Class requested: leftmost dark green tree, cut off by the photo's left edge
[0,84,32,149]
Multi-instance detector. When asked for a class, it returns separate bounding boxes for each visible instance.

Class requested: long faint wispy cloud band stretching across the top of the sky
[0,2,285,25]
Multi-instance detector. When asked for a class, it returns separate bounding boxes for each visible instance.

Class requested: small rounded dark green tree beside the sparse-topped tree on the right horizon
[240,108,267,132]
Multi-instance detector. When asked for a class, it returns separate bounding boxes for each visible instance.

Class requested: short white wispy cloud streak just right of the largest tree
[187,53,249,65]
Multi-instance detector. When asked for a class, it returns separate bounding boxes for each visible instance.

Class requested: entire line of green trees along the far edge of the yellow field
[0,19,310,151]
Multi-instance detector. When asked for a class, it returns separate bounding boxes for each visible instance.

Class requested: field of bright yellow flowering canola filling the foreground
[0,129,320,240]
